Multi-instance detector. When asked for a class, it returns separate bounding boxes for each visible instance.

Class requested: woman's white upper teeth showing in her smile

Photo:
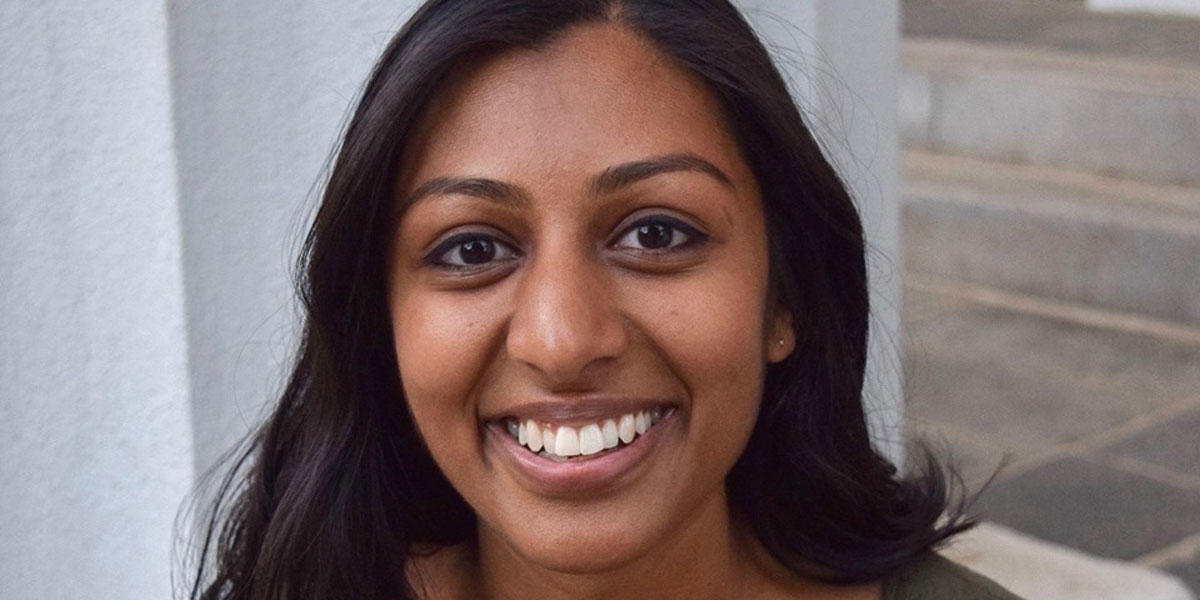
[504,406,673,462]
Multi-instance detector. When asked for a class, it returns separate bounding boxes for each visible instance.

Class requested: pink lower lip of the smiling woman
[485,408,679,497]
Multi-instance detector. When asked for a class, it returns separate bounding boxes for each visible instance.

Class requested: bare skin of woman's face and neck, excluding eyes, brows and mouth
[388,24,878,600]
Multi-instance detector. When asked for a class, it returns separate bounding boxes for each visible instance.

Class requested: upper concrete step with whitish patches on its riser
[900,38,1200,185]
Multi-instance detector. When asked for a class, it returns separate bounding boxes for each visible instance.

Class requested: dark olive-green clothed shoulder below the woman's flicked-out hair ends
[883,552,1021,600]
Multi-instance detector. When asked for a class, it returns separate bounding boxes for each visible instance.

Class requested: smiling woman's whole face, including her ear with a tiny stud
[388,25,793,572]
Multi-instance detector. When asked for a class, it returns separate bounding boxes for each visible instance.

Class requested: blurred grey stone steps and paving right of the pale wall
[900,0,1200,598]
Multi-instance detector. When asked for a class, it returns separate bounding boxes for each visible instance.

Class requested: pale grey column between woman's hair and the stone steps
[738,0,904,462]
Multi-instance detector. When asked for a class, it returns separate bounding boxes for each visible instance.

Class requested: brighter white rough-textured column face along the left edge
[0,0,193,600]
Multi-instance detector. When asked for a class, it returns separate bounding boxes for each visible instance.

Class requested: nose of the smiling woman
[505,243,628,388]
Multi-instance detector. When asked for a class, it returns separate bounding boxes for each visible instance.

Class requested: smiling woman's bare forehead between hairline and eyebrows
[400,24,749,194]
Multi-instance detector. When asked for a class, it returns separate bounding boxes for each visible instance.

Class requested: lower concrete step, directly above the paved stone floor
[901,150,1200,328]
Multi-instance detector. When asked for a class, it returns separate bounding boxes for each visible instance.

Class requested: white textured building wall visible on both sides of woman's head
[0,0,901,600]
